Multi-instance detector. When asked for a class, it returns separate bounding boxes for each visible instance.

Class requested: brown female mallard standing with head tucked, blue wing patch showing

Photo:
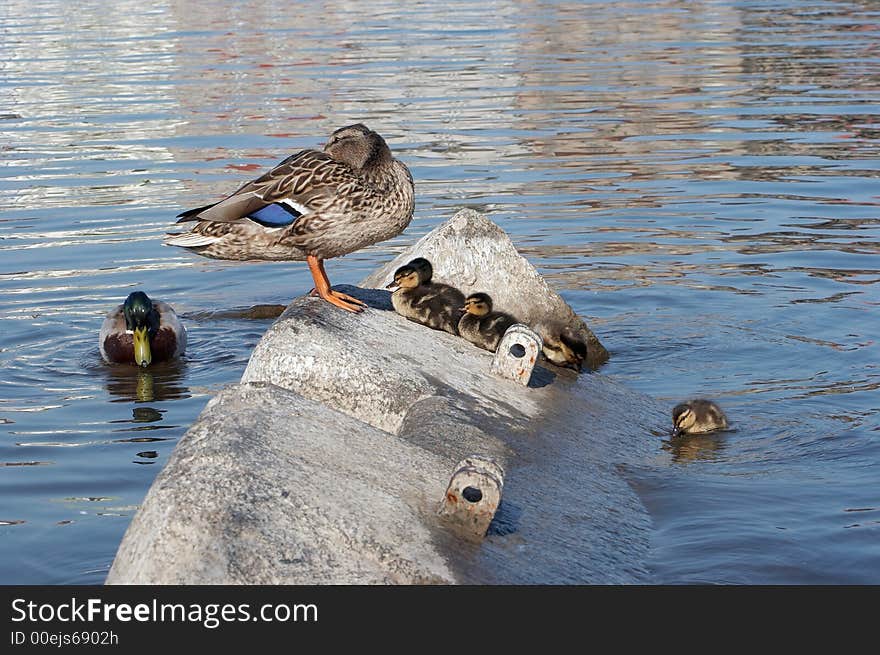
[165,123,415,312]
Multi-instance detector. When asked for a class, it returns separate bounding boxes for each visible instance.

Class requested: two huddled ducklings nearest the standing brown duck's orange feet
[385,257,464,335]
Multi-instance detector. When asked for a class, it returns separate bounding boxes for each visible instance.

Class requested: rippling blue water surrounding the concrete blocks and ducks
[0,0,880,584]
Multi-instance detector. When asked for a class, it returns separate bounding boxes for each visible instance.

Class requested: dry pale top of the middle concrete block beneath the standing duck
[241,285,540,434]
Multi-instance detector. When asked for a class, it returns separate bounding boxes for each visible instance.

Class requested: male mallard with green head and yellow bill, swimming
[98,291,186,366]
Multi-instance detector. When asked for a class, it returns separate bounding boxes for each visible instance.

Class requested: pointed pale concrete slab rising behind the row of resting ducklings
[360,209,608,369]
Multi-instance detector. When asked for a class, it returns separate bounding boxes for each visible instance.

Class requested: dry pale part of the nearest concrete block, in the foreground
[107,384,455,584]
